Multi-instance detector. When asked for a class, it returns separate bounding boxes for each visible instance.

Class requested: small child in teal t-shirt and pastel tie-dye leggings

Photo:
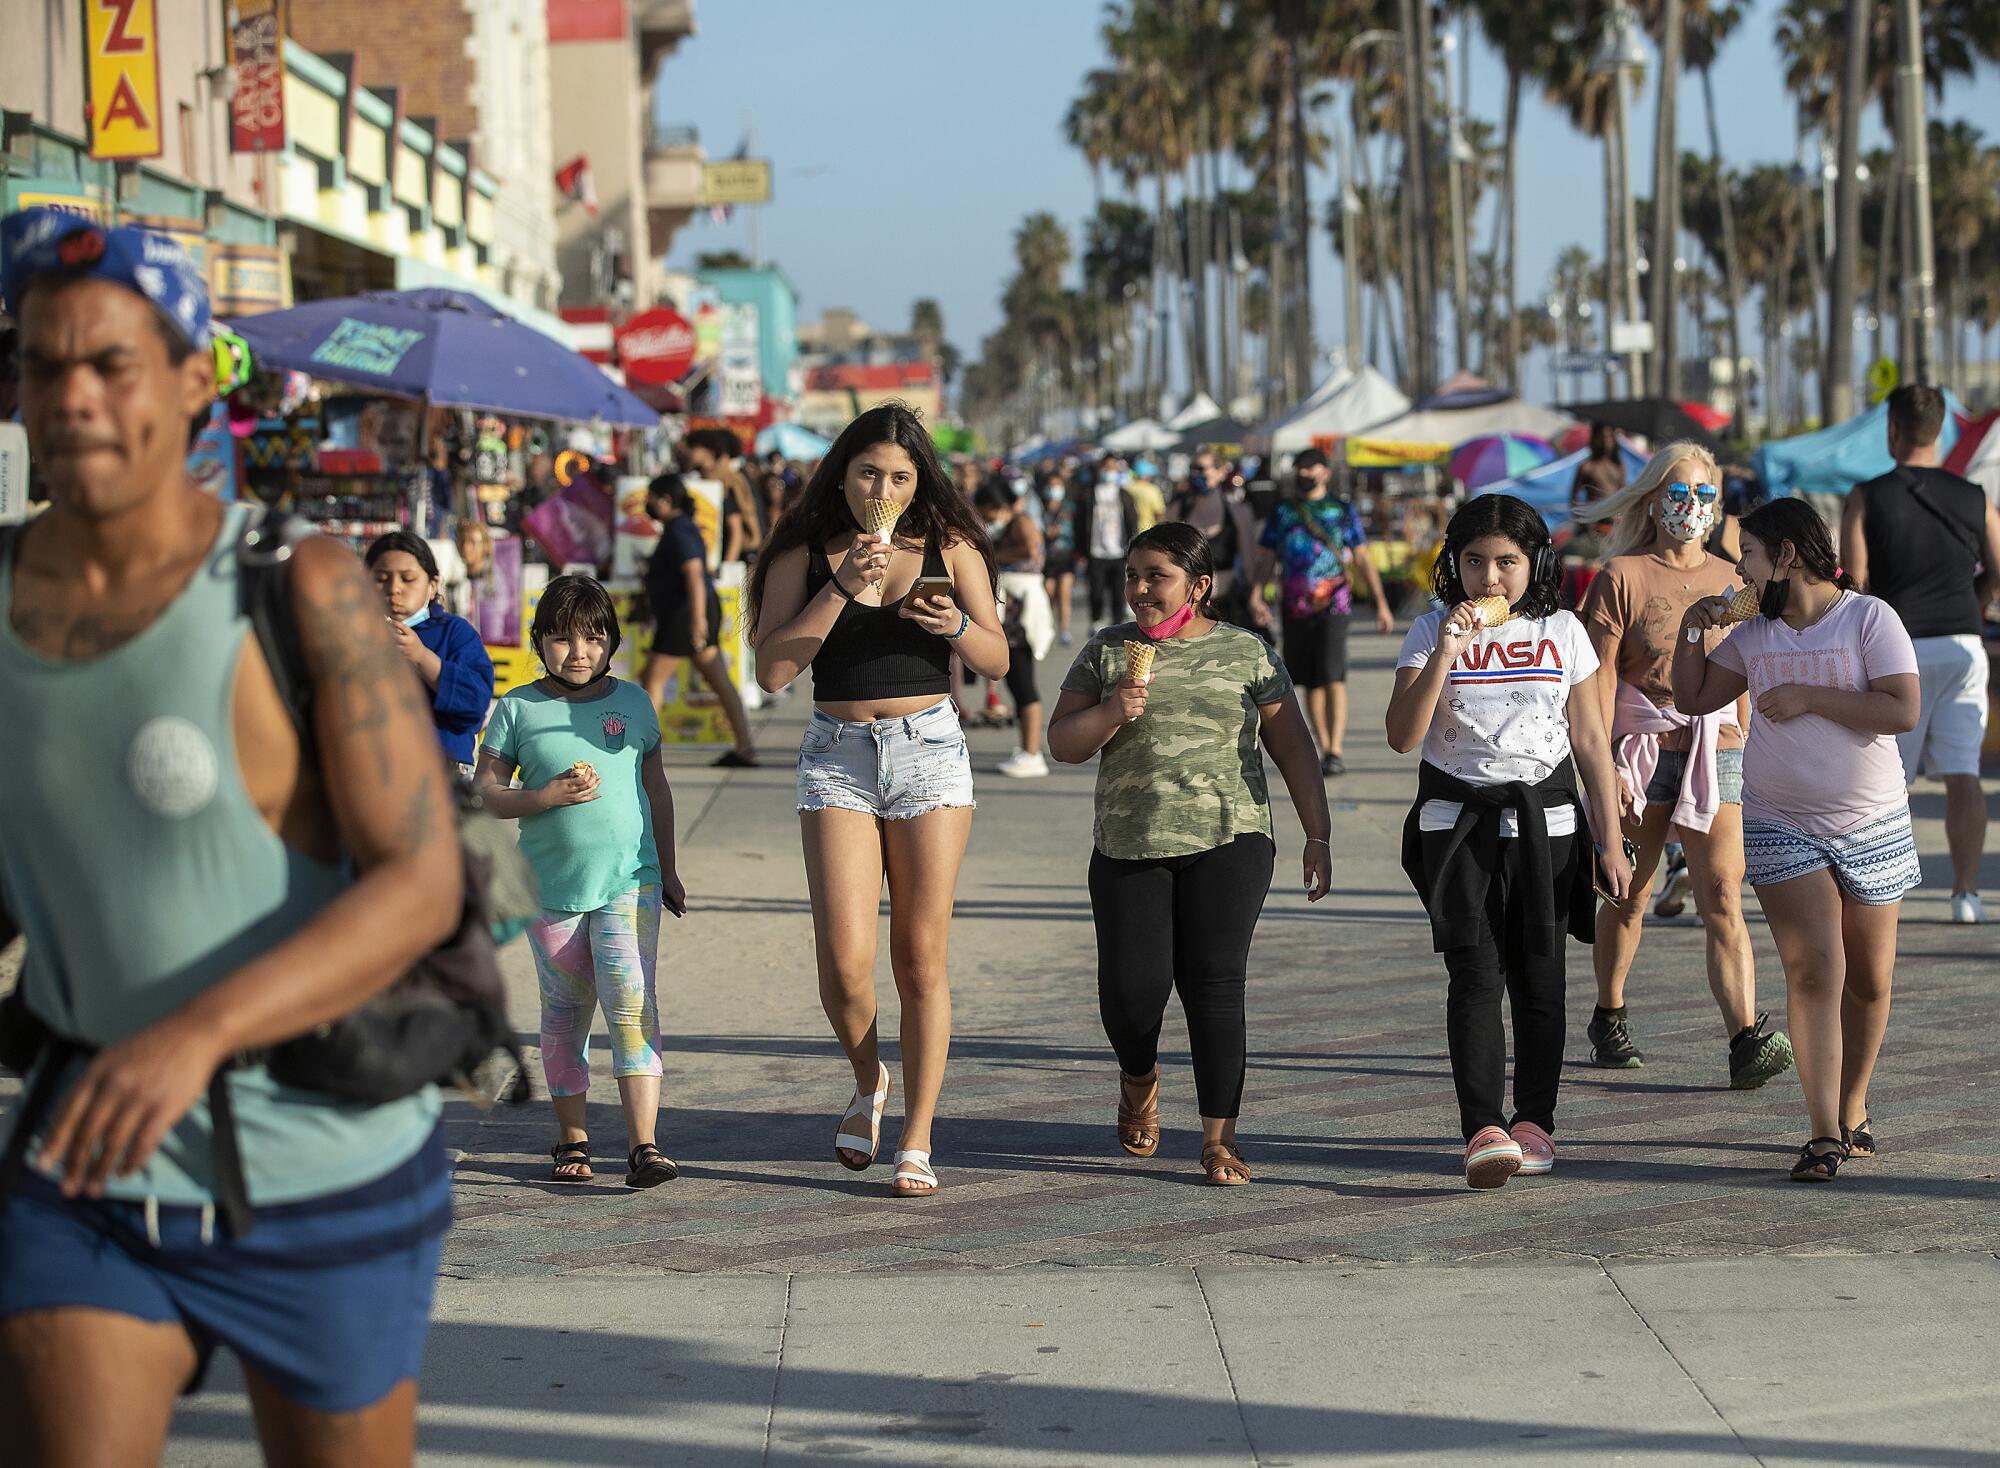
[476,576,688,1188]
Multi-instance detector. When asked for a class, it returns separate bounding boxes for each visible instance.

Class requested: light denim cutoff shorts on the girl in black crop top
[798,698,974,820]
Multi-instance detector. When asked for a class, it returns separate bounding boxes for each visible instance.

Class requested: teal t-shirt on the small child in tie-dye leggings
[484,678,660,912]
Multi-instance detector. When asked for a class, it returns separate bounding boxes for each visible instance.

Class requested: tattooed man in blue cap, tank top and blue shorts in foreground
[0,210,460,1466]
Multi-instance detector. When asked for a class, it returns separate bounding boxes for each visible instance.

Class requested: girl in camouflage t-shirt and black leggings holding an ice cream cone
[1048,524,1332,1188]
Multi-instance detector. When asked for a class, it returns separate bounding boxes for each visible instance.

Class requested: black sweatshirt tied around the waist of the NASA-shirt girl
[1402,760,1596,956]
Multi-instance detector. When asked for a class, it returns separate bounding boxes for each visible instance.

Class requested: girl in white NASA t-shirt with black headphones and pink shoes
[1388,494,1632,1188]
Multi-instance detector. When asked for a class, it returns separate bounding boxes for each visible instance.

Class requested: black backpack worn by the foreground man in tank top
[0,514,536,1238]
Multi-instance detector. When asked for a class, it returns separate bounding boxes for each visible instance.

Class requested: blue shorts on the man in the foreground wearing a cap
[0,1134,452,1412]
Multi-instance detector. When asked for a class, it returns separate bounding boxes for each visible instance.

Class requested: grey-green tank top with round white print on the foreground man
[0,506,438,1206]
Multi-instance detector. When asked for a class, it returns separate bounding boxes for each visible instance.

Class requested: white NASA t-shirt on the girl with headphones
[1396,612,1600,836]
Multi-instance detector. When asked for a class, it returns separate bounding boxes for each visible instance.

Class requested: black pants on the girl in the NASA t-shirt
[1424,830,1576,1142]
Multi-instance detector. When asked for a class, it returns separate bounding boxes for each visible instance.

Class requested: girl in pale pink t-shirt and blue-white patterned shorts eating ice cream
[1674,500,1918,1182]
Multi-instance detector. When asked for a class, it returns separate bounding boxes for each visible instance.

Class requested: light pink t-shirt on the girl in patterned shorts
[1708,592,1916,836]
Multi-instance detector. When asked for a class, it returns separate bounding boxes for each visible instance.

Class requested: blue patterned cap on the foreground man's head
[0,208,210,348]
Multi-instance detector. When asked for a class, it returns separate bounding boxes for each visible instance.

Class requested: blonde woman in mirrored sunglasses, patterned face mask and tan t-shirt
[1580,442,1792,1090]
